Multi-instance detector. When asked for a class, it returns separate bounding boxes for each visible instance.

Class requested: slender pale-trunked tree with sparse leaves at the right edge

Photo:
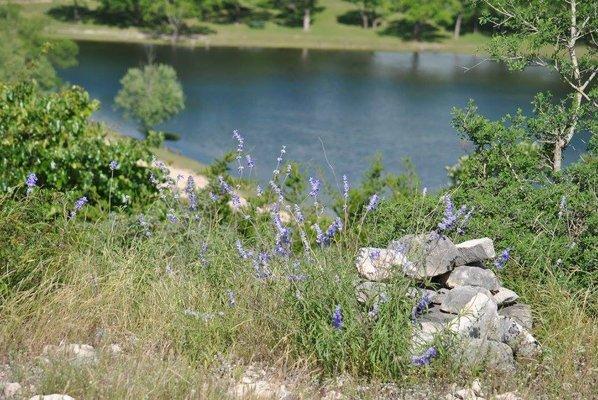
[481,0,598,172]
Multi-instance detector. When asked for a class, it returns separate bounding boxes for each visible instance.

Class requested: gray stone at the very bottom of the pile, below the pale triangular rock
[455,339,515,374]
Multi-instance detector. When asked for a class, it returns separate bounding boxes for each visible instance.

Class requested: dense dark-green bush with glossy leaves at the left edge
[0,83,162,206]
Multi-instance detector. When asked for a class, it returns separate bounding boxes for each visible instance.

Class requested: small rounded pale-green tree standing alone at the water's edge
[114,64,185,132]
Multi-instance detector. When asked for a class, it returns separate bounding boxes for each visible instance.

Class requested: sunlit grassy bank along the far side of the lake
[17,0,488,54]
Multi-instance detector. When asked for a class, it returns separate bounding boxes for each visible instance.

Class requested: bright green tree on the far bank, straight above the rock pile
[396,0,457,41]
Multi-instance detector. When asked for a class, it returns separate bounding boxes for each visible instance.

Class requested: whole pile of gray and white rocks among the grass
[356,232,540,372]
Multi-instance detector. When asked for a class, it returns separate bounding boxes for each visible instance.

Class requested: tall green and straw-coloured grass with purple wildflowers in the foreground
[0,145,598,398]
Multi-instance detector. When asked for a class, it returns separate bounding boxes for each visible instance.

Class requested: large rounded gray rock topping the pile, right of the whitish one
[388,232,459,279]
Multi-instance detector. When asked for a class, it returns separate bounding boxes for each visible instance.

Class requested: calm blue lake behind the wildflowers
[60,42,583,188]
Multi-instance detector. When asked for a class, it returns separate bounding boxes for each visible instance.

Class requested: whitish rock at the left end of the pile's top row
[355,247,407,282]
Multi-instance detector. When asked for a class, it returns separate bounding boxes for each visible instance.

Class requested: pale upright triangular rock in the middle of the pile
[448,288,498,339]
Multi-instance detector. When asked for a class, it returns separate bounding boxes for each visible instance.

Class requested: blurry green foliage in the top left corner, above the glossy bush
[0,5,77,89]
